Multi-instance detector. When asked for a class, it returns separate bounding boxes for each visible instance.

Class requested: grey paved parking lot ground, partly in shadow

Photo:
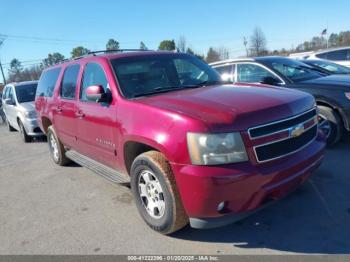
[0,125,350,254]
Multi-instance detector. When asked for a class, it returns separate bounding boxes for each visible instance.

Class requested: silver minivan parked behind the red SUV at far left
[2,81,43,143]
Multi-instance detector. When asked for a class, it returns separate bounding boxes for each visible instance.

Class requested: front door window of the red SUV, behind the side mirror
[80,63,109,101]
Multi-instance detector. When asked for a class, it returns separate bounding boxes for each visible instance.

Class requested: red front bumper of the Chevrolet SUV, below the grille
[172,134,325,228]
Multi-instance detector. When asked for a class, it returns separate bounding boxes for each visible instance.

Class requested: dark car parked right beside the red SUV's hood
[211,56,350,146]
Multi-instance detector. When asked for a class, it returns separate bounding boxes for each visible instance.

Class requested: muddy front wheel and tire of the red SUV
[131,151,188,234]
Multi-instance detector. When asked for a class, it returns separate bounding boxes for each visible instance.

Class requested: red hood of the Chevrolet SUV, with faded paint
[139,85,315,131]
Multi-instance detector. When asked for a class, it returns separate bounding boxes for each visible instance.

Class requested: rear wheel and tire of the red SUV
[47,126,71,166]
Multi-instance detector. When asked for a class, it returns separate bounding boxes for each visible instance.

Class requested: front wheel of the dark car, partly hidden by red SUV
[318,106,344,147]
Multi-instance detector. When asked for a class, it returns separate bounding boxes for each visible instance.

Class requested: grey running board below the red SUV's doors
[66,150,130,184]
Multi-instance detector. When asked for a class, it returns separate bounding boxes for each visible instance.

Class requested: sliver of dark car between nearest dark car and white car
[300,59,350,75]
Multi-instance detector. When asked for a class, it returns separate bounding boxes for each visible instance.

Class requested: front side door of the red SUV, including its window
[76,63,117,168]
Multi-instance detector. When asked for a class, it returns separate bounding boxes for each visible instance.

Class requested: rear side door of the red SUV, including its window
[53,64,80,147]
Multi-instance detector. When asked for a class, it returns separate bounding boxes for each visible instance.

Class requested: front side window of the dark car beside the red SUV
[237,64,276,83]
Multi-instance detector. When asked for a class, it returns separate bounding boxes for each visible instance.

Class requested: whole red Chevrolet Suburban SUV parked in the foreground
[36,50,325,234]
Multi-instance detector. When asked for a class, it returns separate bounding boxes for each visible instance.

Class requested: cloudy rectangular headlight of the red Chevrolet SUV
[187,133,248,165]
